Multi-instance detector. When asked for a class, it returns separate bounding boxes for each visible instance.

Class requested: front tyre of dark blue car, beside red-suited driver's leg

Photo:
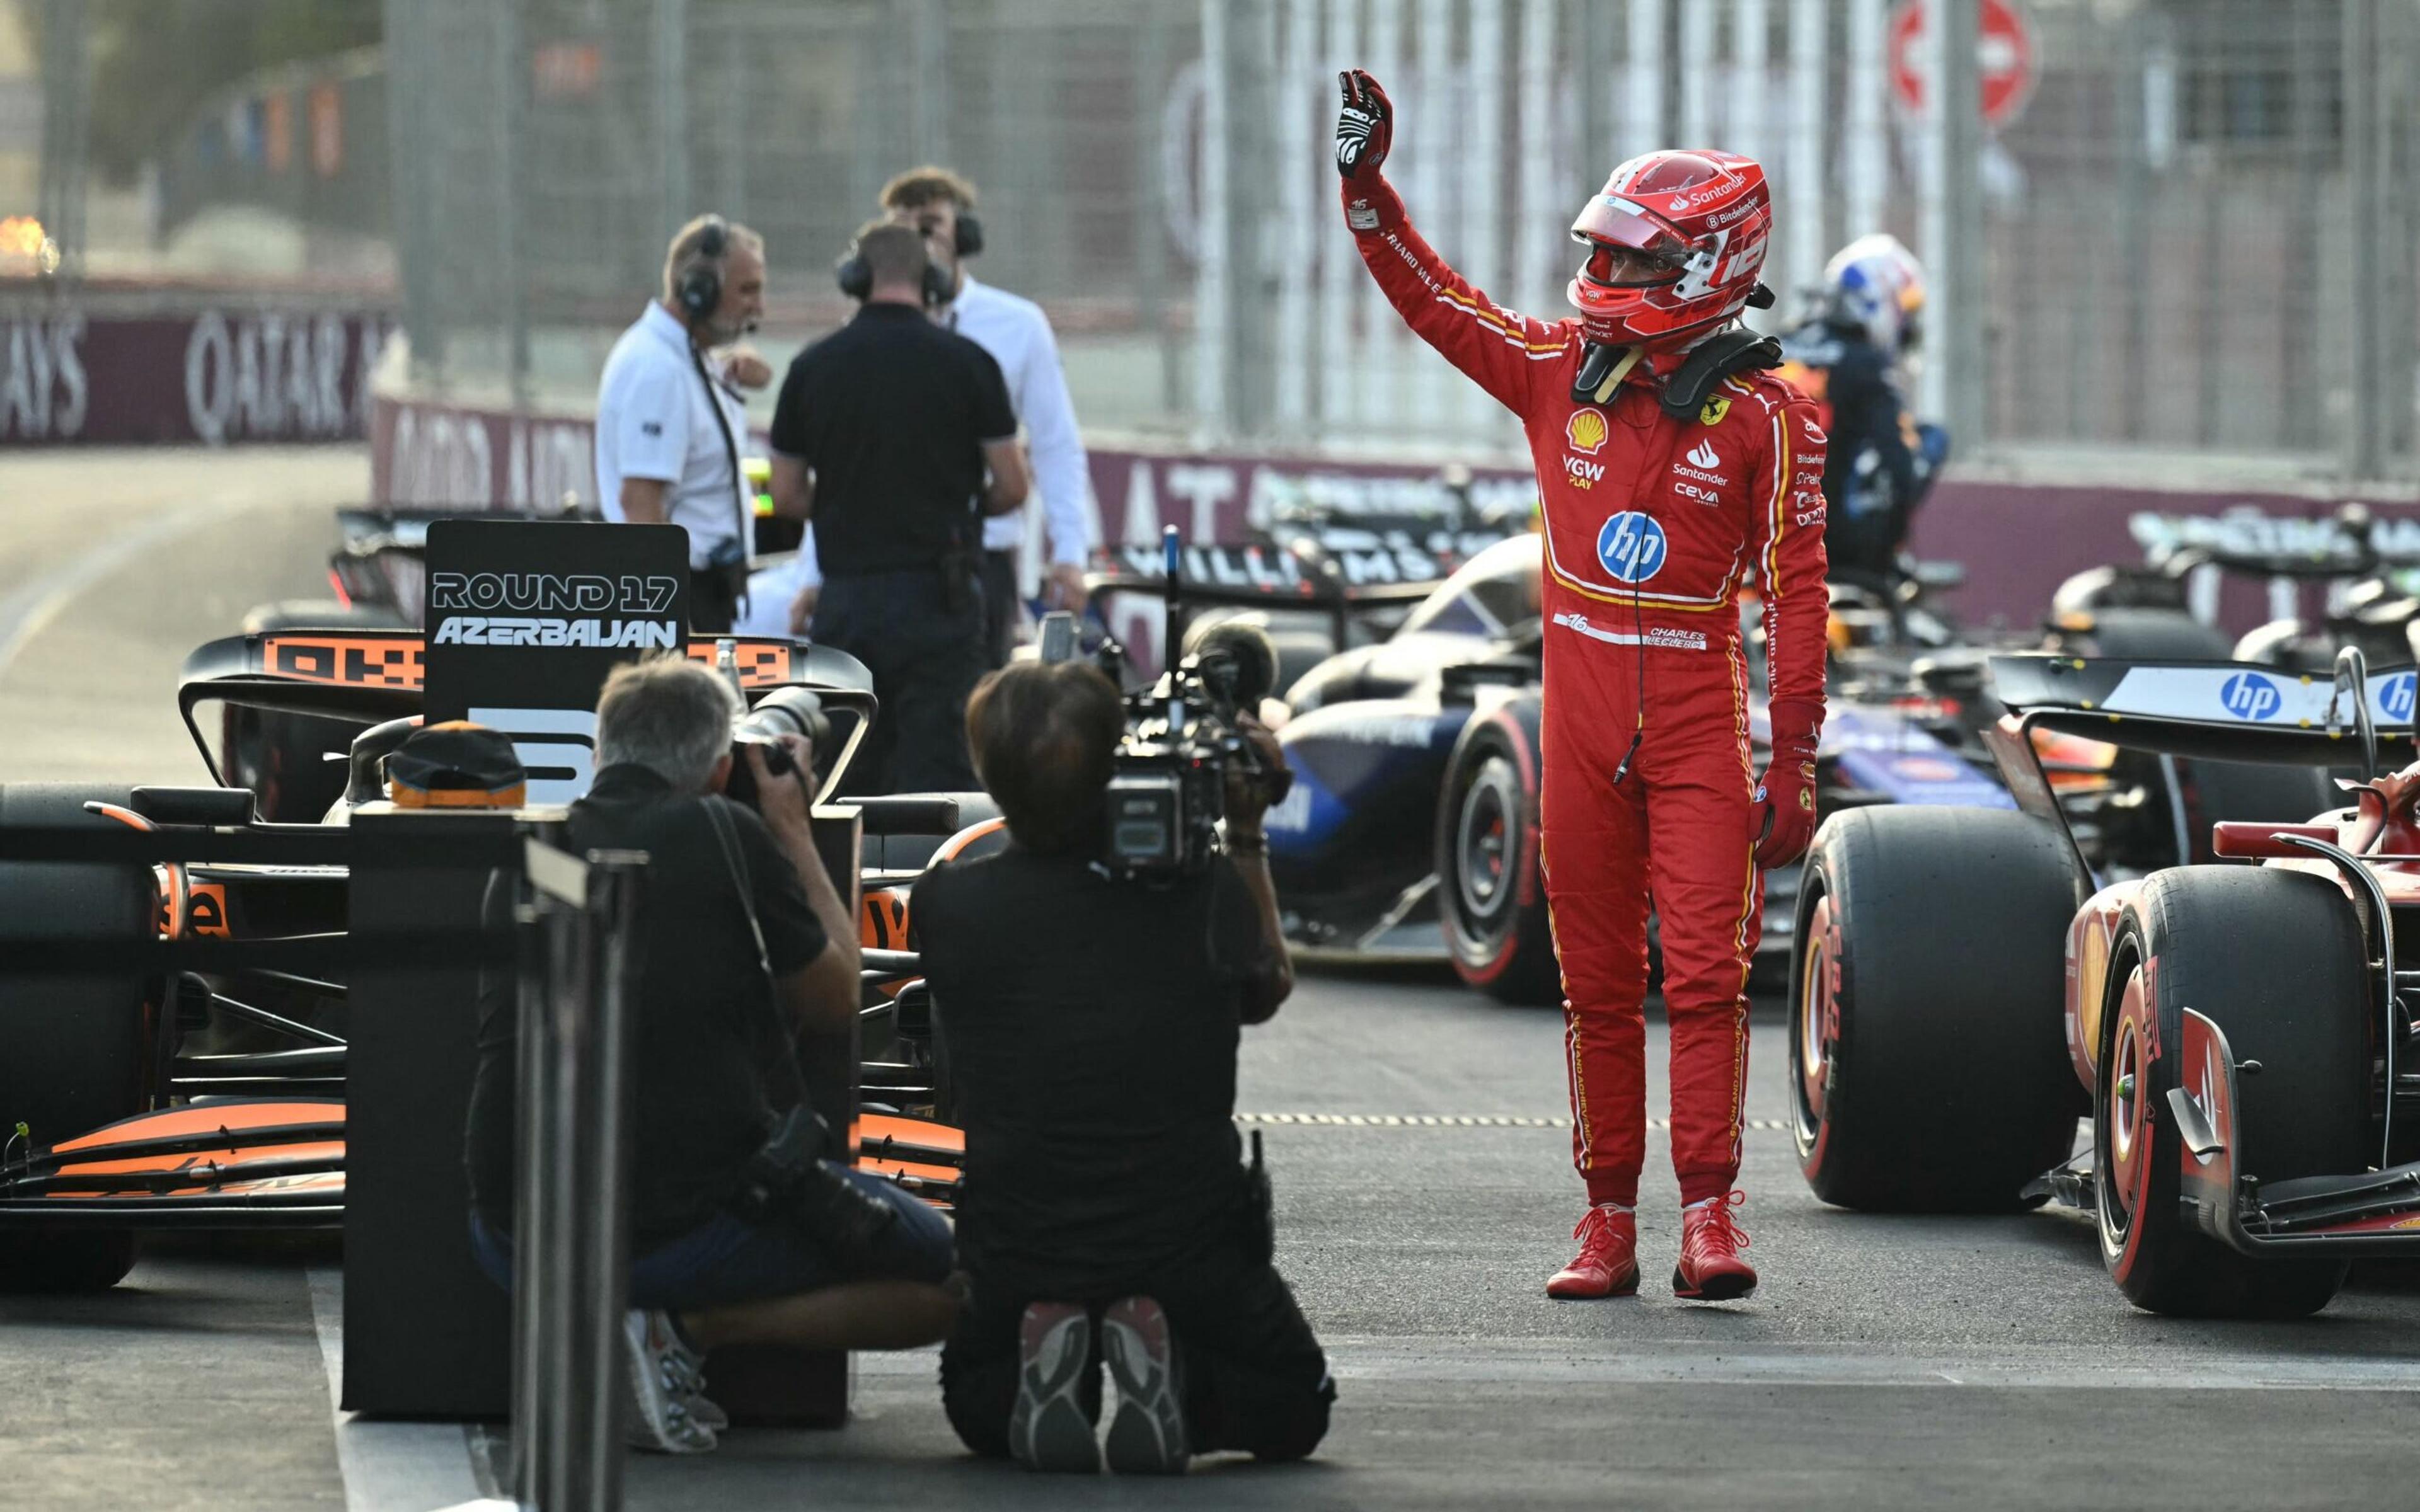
[1438,699,1564,1004]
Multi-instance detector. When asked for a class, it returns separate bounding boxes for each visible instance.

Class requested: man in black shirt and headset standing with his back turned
[772,220,1026,794]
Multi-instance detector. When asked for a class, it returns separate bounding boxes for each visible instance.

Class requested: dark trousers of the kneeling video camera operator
[942,1251,1336,1459]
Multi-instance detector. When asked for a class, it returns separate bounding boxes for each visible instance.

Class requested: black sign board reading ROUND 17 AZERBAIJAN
[421,520,689,803]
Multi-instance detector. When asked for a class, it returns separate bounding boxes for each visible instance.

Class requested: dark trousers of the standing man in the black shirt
[809,566,985,796]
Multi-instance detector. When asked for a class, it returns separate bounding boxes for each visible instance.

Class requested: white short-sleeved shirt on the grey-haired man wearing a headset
[597,300,748,566]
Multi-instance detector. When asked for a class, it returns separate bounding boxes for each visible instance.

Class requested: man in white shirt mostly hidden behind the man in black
[792,167,1098,665]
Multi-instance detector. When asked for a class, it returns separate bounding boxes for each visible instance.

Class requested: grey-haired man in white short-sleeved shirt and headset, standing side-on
[596,215,764,631]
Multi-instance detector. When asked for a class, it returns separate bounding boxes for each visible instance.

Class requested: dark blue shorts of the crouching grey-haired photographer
[470,1171,951,1311]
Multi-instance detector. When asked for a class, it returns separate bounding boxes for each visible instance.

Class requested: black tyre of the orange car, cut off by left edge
[0,784,159,1292]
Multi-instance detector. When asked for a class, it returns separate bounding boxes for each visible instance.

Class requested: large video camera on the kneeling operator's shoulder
[1043,525,1294,881]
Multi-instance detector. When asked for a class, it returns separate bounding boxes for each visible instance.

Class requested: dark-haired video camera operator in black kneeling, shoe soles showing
[910,663,1336,1474]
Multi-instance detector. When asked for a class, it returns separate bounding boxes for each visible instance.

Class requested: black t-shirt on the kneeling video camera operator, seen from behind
[910,847,1265,1294]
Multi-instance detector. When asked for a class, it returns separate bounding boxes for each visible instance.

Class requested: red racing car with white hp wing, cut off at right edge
[1789,648,2420,1316]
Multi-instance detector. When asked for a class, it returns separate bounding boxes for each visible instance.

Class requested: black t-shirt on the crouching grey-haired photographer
[467,764,825,1253]
